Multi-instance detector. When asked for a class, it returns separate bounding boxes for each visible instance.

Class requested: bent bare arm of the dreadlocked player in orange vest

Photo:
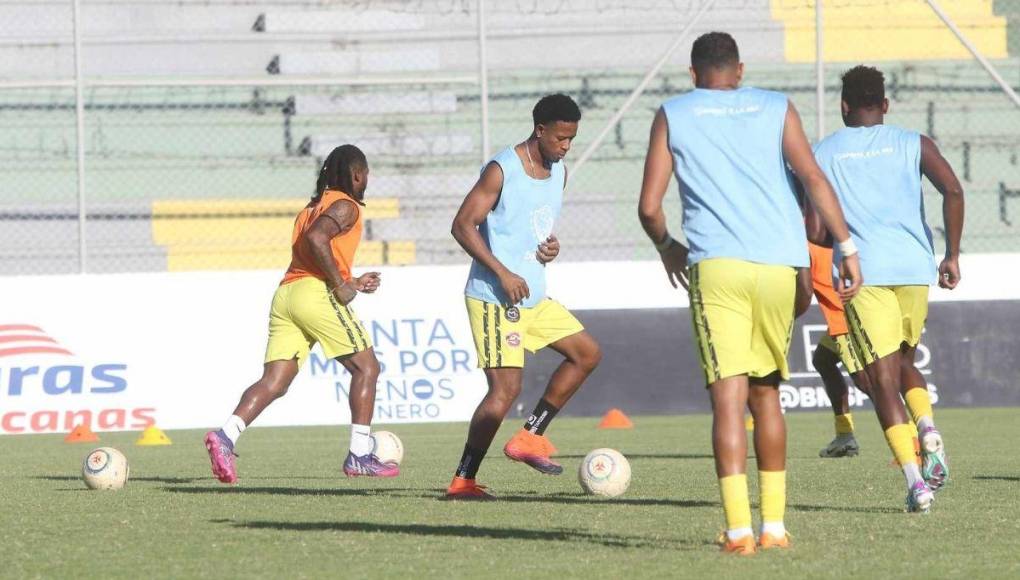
[302,200,379,304]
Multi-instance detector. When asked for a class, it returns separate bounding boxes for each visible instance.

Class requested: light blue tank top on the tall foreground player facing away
[662,88,809,267]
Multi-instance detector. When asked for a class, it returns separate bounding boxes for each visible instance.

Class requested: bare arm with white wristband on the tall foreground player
[782,103,863,301]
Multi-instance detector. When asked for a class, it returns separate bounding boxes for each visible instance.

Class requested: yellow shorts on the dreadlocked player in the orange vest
[265,276,372,366]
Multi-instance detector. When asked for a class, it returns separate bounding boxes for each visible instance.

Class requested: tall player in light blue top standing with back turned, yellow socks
[639,33,861,553]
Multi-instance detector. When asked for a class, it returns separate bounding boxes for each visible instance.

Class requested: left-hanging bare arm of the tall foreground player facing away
[638,109,687,289]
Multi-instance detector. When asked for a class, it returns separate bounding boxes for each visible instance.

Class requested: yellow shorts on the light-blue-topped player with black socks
[465,298,584,369]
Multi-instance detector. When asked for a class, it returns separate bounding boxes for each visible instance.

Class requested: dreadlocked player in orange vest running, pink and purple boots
[205,145,399,483]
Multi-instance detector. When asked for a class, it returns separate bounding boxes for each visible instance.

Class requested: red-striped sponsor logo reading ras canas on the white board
[0,324,156,433]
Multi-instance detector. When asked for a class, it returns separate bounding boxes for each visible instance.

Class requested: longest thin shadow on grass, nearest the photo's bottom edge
[223,520,701,549]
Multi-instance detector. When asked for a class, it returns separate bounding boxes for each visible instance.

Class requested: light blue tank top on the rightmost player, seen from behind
[815,125,935,286]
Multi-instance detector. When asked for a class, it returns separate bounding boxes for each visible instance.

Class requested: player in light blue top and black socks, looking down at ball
[447,95,602,499]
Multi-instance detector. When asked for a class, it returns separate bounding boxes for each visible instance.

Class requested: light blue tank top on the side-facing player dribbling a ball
[464,147,564,308]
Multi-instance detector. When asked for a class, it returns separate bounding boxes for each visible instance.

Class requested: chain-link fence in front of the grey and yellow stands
[0,0,1020,275]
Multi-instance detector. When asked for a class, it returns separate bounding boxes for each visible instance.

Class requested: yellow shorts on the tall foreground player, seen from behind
[691,258,797,384]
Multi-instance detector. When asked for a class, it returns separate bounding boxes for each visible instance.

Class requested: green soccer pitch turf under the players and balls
[0,409,1020,578]
